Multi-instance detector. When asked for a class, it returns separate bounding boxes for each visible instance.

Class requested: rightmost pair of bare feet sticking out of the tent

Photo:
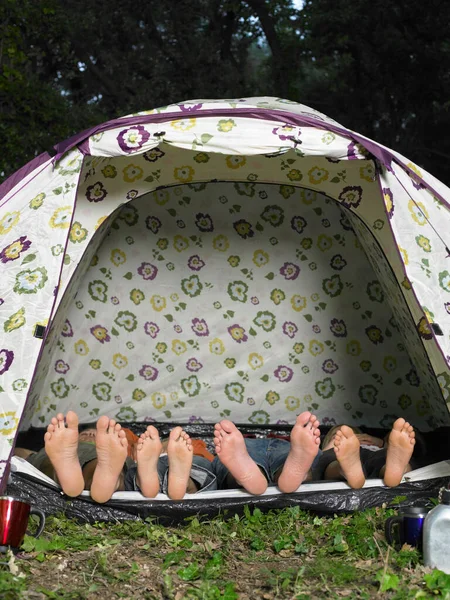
[325,418,416,489]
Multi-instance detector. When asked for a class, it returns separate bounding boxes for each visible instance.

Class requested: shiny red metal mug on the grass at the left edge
[0,496,45,551]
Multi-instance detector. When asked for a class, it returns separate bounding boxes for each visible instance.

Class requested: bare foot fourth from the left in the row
[167,426,194,500]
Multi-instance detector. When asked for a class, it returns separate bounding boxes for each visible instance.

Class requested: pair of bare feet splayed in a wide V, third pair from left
[214,411,320,494]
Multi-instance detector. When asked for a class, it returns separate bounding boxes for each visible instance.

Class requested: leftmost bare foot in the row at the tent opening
[44,410,84,497]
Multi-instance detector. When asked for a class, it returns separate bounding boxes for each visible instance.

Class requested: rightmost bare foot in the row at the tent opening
[383,418,416,487]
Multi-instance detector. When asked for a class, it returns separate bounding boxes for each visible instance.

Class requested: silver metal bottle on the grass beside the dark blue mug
[423,488,450,574]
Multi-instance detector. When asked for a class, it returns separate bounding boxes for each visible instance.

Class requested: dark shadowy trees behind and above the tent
[0,0,450,183]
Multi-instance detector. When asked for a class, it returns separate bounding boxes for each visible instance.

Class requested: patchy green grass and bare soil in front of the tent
[0,507,450,600]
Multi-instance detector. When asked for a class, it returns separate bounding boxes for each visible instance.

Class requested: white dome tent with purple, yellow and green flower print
[0,97,450,520]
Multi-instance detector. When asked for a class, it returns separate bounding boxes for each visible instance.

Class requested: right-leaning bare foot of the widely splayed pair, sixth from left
[277,411,320,493]
